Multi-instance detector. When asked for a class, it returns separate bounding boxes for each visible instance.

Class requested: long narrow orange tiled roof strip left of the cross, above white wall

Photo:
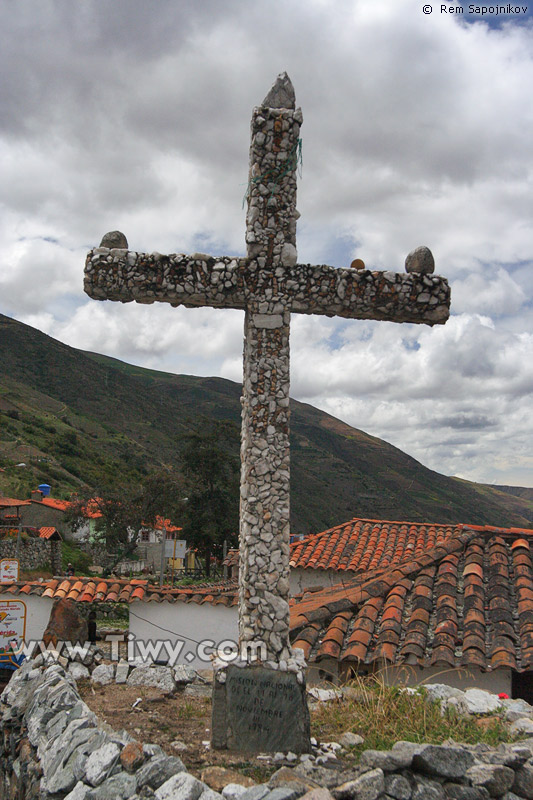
[0,577,238,606]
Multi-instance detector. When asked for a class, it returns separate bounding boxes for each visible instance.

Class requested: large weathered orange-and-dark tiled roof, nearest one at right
[291,526,533,671]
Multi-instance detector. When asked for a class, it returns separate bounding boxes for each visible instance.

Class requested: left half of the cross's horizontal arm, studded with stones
[83,247,248,309]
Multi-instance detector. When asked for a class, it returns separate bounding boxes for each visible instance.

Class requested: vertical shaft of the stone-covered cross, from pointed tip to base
[239,75,302,665]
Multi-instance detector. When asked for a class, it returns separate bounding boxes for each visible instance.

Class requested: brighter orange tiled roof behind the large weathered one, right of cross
[290,518,463,572]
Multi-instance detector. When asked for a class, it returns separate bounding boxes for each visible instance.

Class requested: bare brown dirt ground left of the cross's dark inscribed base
[78,681,279,782]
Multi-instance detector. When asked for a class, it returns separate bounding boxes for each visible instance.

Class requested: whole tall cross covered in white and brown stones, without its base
[85,73,450,669]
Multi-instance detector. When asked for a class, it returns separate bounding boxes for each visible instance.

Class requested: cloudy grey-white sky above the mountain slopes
[0,0,533,486]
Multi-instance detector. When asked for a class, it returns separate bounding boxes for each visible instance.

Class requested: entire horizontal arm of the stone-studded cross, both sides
[84,247,450,325]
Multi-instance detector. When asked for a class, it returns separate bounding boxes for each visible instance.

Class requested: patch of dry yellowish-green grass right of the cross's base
[311,676,513,754]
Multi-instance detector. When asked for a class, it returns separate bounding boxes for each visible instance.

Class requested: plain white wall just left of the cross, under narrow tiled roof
[129,602,238,669]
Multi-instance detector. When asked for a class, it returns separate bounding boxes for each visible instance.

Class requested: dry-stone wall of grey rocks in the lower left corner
[0,657,225,800]
